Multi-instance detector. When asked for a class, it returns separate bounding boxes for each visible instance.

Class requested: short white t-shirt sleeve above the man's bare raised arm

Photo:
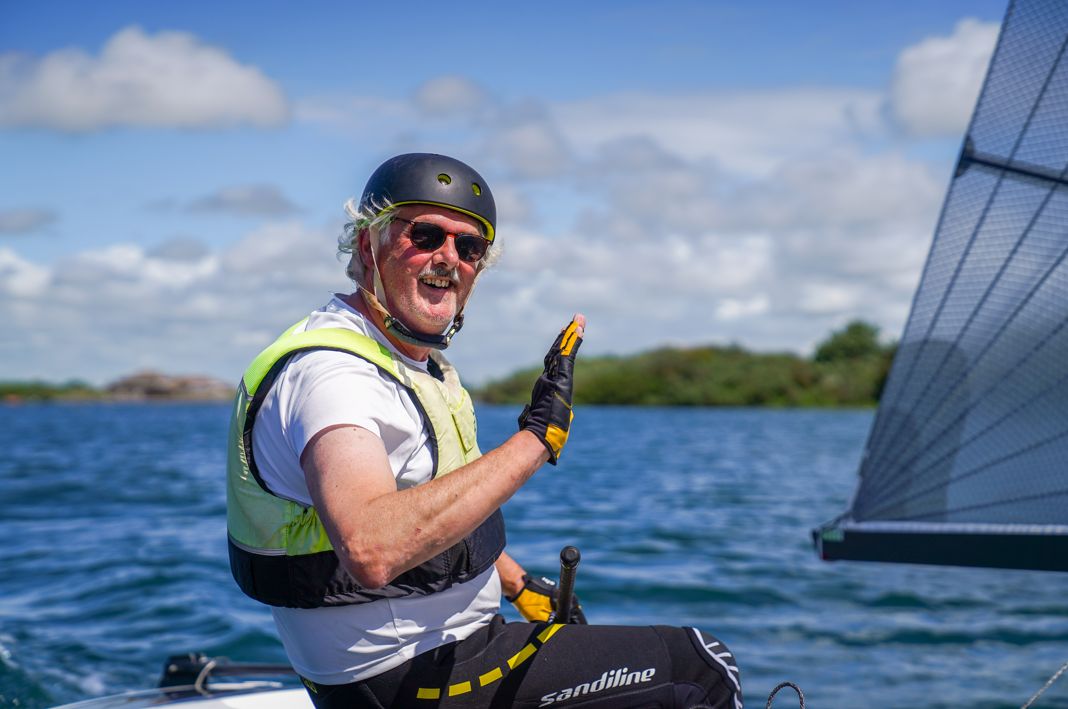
[283,351,411,459]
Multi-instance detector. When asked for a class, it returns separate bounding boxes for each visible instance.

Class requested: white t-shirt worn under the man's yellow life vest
[252,296,501,684]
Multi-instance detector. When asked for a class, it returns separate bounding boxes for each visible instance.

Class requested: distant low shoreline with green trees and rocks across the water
[0,320,897,409]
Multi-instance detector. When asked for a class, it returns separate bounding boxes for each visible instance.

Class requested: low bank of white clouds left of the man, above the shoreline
[0,222,348,381]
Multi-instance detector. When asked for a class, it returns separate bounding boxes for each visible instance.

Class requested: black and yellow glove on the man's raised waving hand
[519,320,582,466]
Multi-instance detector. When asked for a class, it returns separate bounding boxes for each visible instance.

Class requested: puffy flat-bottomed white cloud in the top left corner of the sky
[0,27,289,132]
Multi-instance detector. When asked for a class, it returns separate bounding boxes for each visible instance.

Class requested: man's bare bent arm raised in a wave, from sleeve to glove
[301,426,549,588]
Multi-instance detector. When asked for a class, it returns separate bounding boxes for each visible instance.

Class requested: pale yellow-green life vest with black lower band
[226,319,505,608]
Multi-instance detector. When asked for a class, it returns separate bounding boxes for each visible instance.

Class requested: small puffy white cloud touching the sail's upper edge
[891,19,999,137]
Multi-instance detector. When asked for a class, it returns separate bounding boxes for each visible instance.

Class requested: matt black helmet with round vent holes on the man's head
[360,153,497,241]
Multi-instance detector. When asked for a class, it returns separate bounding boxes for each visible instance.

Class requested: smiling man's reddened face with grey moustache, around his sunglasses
[364,204,482,334]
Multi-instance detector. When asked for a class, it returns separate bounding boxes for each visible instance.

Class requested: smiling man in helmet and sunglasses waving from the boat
[227,154,741,709]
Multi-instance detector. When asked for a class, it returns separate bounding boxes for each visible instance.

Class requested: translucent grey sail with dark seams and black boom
[814,0,1068,570]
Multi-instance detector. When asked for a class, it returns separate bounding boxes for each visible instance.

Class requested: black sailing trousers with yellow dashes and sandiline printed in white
[296,615,742,709]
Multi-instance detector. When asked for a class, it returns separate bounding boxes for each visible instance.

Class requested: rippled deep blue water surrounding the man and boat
[0,404,1068,708]
